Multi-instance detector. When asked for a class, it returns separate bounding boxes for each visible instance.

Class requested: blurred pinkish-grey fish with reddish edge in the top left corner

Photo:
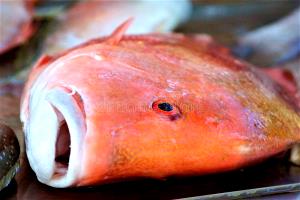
[0,0,35,54]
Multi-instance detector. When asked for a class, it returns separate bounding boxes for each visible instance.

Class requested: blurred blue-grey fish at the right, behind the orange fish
[236,8,300,66]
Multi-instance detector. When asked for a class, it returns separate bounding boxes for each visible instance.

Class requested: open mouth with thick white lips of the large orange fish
[26,88,86,187]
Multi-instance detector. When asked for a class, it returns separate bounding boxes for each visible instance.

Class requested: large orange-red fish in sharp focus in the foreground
[21,27,300,187]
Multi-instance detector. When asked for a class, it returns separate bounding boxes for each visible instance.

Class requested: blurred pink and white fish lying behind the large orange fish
[43,0,192,54]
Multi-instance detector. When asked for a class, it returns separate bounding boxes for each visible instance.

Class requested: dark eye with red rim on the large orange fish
[152,100,181,121]
